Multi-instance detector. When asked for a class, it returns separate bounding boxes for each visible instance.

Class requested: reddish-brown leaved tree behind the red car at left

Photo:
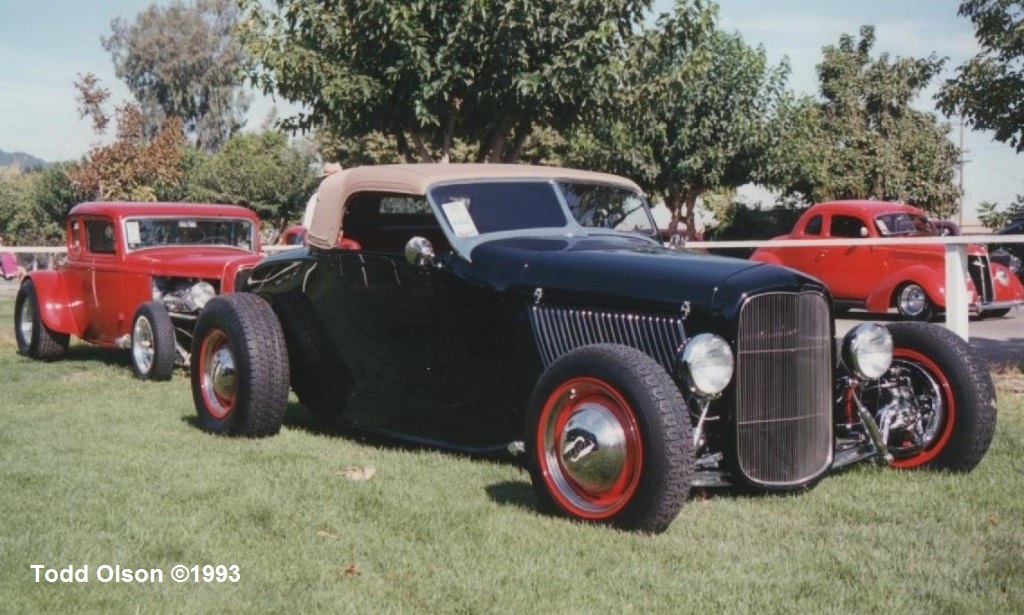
[69,75,184,201]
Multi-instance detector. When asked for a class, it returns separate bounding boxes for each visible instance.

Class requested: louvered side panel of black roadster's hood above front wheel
[529,306,685,374]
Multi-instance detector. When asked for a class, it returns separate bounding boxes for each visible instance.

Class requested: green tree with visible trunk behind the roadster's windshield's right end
[568,1,774,237]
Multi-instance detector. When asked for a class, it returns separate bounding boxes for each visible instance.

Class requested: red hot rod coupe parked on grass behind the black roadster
[14,203,261,380]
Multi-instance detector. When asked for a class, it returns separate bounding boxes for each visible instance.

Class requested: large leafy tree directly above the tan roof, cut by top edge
[242,0,650,162]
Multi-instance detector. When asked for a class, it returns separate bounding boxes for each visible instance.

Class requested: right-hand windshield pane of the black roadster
[558,182,657,235]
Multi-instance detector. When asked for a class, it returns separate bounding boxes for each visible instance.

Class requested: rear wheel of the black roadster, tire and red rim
[191,293,288,437]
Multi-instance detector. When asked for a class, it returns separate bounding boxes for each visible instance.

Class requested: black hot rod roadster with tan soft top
[191,164,995,532]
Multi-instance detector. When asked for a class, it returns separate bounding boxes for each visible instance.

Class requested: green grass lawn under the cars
[0,297,1024,613]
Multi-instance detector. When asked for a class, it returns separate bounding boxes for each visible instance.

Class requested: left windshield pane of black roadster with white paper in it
[430,181,568,237]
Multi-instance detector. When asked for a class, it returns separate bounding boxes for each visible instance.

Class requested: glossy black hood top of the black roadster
[464,235,824,315]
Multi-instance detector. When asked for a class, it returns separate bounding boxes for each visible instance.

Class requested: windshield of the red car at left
[125,218,255,252]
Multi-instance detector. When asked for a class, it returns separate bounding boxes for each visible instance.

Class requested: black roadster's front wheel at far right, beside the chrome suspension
[863,322,996,472]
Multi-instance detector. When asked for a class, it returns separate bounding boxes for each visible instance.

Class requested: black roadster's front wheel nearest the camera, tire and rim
[525,345,694,532]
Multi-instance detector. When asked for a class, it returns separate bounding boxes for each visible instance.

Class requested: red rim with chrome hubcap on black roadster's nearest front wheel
[535,378,643,520]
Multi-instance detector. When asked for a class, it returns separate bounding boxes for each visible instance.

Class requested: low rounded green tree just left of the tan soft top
[188,131,317,228]
